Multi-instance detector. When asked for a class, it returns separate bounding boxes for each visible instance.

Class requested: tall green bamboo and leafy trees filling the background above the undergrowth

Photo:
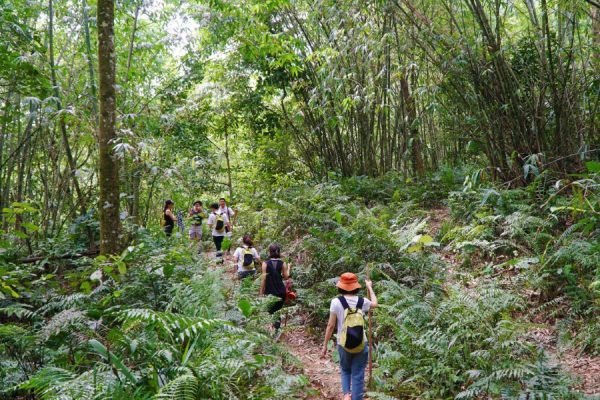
[0,0,600,251]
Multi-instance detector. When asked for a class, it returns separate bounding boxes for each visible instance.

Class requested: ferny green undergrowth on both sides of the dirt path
[0,165,600,399]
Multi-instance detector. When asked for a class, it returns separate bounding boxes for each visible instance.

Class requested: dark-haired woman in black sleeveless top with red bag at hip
[258,243,290,333]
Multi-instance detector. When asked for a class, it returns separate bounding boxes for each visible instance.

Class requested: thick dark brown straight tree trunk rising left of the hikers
[97,0,121,254]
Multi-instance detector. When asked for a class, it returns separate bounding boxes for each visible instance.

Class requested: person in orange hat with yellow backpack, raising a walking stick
[322,272,377,400]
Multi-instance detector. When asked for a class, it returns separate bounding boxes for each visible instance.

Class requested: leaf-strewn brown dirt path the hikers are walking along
[202,251,340,400]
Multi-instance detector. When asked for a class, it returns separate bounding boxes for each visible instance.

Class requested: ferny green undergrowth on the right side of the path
[245,167,600,399]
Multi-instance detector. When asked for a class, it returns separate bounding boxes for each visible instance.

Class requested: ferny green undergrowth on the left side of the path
[0,234,306,399]
